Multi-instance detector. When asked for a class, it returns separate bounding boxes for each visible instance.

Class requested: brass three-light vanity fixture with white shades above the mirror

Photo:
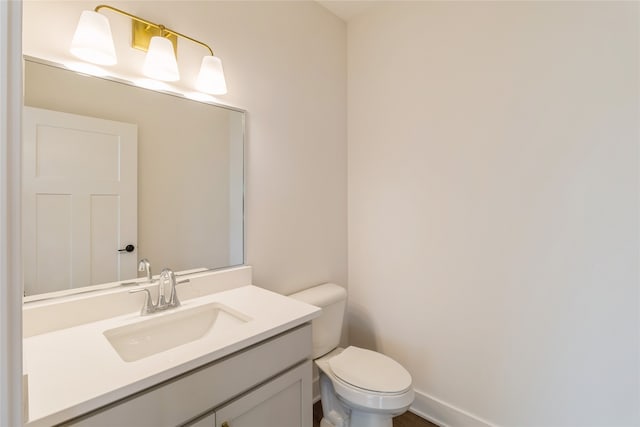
[70,4,227,95]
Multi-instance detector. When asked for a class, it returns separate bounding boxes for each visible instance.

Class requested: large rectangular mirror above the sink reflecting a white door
[23,58,245,299]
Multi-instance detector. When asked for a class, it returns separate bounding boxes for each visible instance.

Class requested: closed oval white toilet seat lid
[328,346,411,394]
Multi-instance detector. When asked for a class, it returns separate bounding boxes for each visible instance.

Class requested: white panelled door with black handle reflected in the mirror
[23,107,137,295]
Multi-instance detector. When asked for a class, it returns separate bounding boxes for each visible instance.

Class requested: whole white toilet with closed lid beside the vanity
[290,283,414,427]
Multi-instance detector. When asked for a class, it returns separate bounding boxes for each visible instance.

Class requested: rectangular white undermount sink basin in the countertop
[104,303,250,362]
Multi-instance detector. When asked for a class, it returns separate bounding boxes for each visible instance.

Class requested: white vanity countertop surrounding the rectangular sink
[23,285,320,427]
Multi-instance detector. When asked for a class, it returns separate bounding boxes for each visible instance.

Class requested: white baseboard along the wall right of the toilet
[409,390,496,427]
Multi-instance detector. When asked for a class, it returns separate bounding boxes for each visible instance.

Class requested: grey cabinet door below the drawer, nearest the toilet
[215,361,312,427]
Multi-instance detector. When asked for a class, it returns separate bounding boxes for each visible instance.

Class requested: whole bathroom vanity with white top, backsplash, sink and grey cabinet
[24,267,320,427]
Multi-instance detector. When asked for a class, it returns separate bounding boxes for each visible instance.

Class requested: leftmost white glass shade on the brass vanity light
[69,10,118,65]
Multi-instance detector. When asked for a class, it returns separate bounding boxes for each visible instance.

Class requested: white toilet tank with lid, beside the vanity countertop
[289,283,347,359]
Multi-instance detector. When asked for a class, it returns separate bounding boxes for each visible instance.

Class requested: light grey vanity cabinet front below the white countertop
[63,323,312,427]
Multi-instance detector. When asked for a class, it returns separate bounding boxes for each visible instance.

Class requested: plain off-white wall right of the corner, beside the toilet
[348,2,640,427]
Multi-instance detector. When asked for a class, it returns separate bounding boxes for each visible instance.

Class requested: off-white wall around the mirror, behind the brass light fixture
[24,0,347,293]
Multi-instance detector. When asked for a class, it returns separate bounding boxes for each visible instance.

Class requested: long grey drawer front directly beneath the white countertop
[63,323,311,427]
